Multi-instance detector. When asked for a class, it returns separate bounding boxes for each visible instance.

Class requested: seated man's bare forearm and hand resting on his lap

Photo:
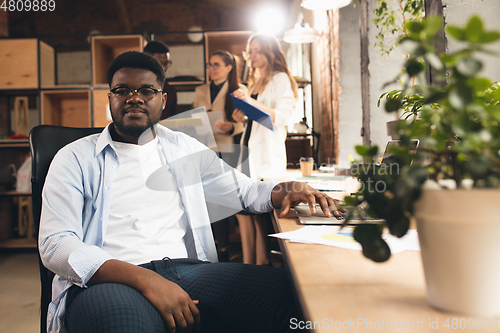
[88,259,201,333]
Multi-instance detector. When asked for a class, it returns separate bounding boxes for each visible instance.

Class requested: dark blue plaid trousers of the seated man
[62,259,300,333]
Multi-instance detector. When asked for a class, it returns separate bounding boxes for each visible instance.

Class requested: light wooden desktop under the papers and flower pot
[273,210,500,333]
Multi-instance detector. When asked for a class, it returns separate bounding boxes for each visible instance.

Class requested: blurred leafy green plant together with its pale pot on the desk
[345,17,500,316]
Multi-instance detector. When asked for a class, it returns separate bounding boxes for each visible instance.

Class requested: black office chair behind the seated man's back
[29,125,103,333]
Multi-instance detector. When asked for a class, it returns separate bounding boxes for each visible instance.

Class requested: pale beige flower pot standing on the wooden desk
[415,190,500,317]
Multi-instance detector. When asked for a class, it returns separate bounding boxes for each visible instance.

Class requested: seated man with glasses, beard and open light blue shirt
[39,52,337,333]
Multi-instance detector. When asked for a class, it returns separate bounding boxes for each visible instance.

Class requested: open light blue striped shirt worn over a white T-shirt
[39,125,277,332]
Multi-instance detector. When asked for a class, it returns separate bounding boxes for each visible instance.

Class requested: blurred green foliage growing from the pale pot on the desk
[345,17,500,262]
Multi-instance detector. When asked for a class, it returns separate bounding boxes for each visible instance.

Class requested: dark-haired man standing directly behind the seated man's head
[144,40,177,120]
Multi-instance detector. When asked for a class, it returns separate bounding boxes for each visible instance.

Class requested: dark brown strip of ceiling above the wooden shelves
[8,0,296,44]
